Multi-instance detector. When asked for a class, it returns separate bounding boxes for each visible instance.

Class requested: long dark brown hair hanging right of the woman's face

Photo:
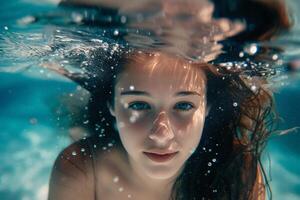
[169,62,276,199]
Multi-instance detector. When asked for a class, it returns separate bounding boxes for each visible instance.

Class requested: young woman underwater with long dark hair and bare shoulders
[49,1,285,200]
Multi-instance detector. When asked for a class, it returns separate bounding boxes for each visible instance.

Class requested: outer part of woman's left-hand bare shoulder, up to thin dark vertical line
[48,138,94,200]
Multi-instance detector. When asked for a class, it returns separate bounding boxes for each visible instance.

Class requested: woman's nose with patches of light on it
[149,111,174,146]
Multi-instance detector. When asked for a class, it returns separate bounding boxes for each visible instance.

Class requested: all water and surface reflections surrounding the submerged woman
[0,0,300,200]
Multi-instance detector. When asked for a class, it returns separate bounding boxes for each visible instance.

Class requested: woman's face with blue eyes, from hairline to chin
[111,54,207,179]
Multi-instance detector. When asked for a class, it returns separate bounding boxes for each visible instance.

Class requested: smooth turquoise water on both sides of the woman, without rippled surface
[0,0,300,200]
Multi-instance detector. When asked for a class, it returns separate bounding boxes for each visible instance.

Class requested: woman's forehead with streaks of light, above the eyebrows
[116,54,206,92]
